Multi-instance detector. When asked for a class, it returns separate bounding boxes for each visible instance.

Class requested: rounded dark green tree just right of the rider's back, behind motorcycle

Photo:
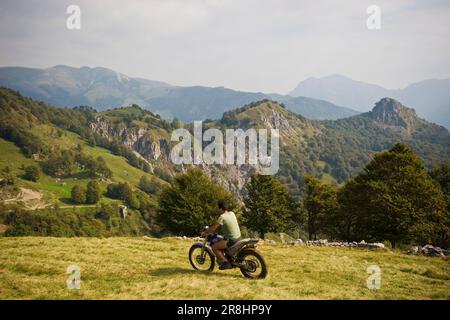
[243,174,299,239]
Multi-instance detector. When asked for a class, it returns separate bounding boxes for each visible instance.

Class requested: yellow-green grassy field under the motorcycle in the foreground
[0,237,450,299]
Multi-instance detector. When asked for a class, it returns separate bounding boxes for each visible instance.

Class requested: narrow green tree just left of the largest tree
[303,176,338,240]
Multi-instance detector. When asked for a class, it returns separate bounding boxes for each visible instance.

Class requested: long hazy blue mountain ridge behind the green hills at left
[0,66,357,121]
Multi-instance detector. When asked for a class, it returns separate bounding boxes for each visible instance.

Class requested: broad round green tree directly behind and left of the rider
[157,168,239,236]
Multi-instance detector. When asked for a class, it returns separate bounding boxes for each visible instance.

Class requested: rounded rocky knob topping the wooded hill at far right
[368,98,419,129]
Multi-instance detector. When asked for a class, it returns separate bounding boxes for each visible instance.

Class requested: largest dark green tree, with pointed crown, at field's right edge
[339,143,446,247]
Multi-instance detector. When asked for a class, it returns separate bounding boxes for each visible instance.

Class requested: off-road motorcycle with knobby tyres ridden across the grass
[189,228,267,279]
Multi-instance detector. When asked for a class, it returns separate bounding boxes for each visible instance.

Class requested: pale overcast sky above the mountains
[0,0,450,94]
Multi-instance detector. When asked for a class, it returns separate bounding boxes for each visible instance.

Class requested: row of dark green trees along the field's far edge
[157,143,450,247]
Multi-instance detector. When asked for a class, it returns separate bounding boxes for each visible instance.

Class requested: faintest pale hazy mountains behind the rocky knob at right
[289,75,450,128]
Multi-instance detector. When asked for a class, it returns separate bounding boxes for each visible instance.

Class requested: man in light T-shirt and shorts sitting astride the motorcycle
[202,201,241,270]
